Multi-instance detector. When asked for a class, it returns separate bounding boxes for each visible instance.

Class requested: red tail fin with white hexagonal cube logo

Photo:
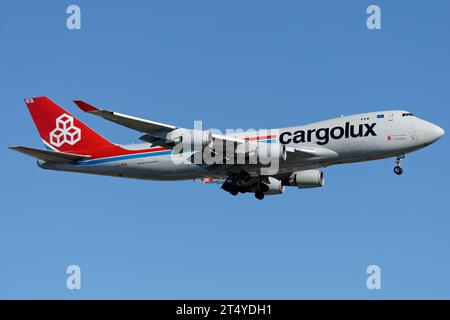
[25,97,113,152]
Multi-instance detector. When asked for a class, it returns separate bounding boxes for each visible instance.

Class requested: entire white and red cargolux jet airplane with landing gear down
[10,97,444,200]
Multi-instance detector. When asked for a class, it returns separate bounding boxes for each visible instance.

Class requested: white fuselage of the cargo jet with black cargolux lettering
[38,110,444,180]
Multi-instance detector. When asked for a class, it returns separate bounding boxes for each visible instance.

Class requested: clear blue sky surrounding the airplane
[0,0,450,299]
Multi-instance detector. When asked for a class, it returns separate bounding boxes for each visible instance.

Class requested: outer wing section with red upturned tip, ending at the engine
[74,100,177,136]
